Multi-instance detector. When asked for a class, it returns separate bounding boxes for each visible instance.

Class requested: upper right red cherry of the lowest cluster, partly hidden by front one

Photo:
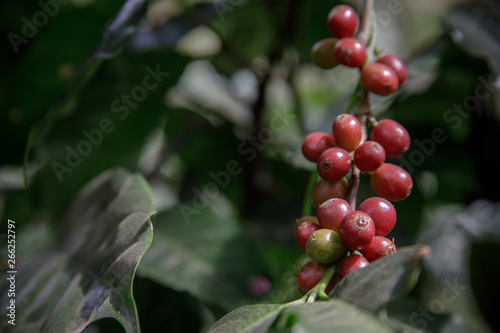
[358,197,397,236]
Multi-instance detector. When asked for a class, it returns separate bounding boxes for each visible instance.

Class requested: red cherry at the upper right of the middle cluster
[370,119,410,158]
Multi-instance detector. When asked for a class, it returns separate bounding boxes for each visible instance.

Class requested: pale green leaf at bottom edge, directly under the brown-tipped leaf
[278,299,393,333]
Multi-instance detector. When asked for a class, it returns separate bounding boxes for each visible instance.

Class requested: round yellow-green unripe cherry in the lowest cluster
[306,229,347,264]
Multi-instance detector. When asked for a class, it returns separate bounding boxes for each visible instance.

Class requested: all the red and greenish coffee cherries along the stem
[295,1,413,294]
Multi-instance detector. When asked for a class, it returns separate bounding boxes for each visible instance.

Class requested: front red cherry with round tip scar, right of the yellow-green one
[339,211,375,251]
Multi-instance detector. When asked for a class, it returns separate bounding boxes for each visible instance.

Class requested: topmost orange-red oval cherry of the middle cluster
[332,113,363,152]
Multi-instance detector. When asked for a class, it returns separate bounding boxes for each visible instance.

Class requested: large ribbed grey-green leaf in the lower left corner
[0,170,154,332]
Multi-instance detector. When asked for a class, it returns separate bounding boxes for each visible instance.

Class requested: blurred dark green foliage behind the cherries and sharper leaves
[0,0,500,332]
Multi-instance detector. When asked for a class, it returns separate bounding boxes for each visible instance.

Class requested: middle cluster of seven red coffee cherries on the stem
[302,114,413,204]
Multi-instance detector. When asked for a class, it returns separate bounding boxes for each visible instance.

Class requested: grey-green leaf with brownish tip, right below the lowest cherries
[332,245,431,313]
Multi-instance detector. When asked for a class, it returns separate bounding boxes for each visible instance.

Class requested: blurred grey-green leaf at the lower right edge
[419,201,500,332]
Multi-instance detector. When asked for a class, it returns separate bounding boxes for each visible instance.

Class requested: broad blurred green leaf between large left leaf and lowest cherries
[138,208,270,310]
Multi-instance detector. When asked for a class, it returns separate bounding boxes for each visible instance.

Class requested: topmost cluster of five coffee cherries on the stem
[311,5,407,96]
